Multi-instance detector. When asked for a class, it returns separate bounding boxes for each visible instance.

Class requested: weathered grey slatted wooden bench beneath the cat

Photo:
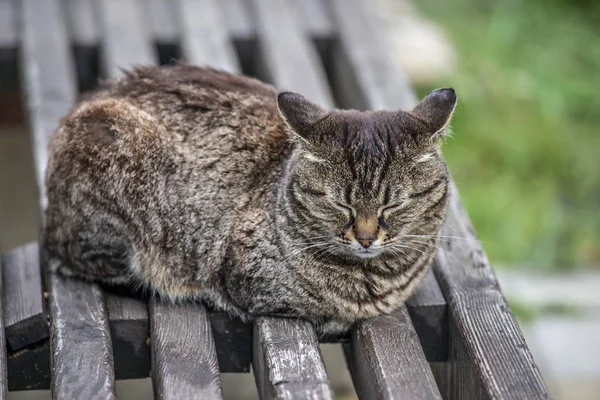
[0,0,548,399]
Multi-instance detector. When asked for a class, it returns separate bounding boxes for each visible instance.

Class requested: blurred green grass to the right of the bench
[416,0,600,268]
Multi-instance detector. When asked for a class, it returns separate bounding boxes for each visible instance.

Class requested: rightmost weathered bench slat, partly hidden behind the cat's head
[331,0,548,399]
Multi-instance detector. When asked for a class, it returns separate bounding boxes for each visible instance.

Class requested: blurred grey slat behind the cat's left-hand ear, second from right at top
[253,0,333,107]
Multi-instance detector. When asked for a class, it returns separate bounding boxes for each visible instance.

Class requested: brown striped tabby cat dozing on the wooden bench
[43,64,456,335]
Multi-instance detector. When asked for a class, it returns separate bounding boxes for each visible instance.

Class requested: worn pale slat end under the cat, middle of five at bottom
[252,317,334,399]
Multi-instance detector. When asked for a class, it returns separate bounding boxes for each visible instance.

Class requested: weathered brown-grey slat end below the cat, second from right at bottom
[344,307,442,400]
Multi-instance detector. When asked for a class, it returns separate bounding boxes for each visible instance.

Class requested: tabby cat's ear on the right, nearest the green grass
[410,88,456,139]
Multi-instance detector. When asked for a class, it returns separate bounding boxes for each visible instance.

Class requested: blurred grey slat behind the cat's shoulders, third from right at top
[178,0,240,72]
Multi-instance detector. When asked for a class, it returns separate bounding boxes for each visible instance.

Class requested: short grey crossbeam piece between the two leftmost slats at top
[63,0,100,47]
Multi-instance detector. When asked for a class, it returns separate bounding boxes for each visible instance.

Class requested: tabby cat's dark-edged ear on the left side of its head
[277,92,328,141]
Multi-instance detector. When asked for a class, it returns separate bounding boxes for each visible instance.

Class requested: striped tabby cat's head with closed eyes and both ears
[277,89,456,260]
